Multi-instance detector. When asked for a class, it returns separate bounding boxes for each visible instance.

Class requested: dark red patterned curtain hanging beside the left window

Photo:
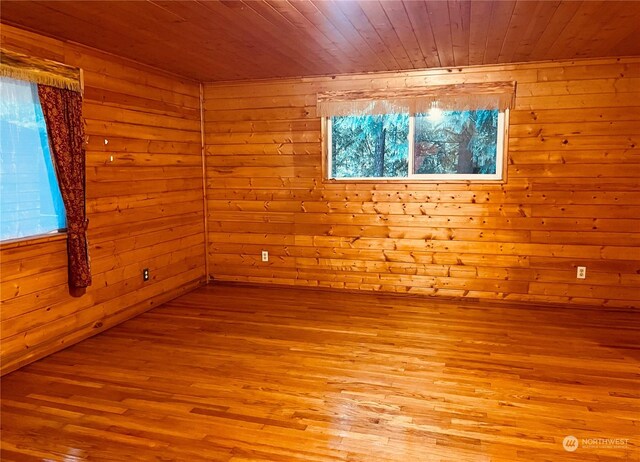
[38,85,91,289]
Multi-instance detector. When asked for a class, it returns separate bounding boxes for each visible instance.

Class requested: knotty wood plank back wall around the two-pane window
[205,58,640,307]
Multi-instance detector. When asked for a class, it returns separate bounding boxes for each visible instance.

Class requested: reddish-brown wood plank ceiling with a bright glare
[0,0,640,81]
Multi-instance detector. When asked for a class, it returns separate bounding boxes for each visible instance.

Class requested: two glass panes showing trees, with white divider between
[328,108,506,180]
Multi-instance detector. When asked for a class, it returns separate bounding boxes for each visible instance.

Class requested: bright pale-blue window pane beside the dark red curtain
[0,77,66,240]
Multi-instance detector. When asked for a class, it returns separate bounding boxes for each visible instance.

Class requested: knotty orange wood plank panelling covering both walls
[0,25,640,373]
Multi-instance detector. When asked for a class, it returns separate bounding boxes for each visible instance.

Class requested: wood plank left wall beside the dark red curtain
[0,25,205,373]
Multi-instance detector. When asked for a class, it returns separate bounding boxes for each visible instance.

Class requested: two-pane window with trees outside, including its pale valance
[318,82,514,181]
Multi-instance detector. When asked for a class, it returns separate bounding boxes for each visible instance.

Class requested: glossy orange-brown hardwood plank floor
[1,284,640,462]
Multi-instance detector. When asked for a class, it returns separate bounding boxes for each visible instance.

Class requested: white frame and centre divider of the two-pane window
[322,108,509,183]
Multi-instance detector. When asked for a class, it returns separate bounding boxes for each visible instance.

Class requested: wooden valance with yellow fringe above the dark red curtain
[0,48,82,92]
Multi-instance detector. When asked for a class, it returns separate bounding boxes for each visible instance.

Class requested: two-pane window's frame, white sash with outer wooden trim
[320,108,510,184]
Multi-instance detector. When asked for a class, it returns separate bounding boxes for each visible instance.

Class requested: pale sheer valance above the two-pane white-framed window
[317,82,516,117]
